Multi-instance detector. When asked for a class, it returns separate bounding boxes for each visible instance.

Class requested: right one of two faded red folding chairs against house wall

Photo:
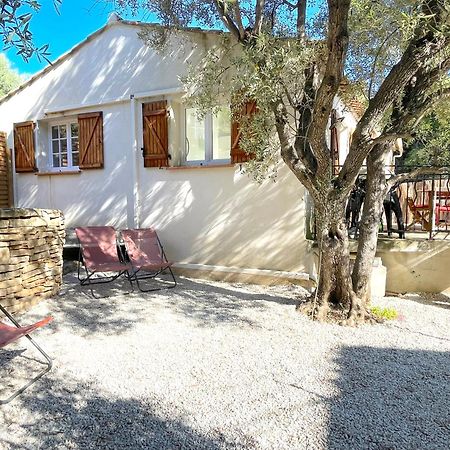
[121,228,177,292]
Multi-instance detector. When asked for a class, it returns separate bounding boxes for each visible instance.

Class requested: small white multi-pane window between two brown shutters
[50,122,79,170]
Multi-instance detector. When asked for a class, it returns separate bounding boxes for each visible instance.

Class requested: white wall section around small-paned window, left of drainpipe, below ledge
[11,104,133,227]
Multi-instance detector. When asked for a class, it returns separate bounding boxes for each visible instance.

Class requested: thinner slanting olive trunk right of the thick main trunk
[352,142,391,306]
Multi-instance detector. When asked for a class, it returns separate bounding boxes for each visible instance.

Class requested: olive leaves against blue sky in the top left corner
[0,0,62,61]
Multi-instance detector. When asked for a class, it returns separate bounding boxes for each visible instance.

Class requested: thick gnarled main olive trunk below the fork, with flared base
[312,196,366,325]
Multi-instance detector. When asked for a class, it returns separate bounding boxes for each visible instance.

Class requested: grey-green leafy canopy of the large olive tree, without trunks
[125,0,450,181]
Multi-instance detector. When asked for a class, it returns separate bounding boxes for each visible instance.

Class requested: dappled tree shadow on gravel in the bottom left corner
[0,380,243,450]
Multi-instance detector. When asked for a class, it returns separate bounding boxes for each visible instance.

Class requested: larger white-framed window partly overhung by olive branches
[185,107,231,164]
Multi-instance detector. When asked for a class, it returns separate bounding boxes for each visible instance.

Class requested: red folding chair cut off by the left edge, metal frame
[0,304,53,405]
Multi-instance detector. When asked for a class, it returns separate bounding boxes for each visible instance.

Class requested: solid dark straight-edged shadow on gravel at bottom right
[327,347,450,450]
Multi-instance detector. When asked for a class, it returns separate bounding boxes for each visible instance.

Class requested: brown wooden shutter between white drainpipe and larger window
[142,100,169,167]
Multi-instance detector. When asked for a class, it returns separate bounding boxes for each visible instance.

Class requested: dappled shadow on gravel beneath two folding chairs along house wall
[46,272,301,336]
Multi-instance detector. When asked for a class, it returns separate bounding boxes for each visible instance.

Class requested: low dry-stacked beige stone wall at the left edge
[0,208,65,313]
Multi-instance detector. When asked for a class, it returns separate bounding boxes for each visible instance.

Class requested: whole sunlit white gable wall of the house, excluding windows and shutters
[0,24,308,271]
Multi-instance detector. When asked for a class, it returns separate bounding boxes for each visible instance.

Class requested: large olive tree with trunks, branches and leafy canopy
[117,0,450,324]
